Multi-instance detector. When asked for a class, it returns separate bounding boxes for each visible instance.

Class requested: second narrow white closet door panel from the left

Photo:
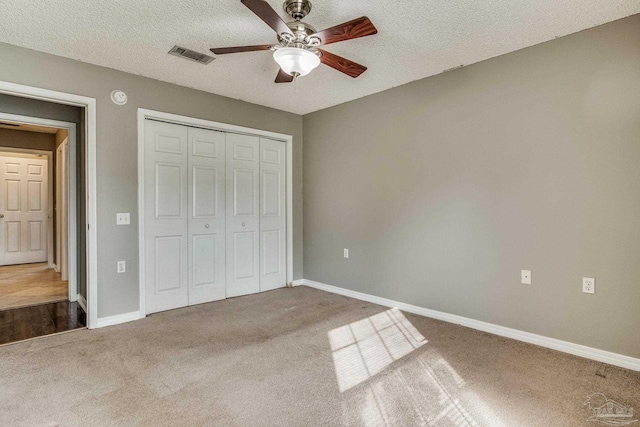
[188,128,226,305]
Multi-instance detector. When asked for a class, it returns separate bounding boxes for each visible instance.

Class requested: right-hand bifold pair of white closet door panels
[227,134,287,297]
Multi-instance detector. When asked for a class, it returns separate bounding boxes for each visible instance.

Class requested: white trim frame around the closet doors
[138,108,293,318]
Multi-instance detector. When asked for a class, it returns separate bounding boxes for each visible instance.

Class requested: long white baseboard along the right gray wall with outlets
[302,279,640,371]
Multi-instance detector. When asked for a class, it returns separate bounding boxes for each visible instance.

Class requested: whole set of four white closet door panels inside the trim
[146,119,286,313]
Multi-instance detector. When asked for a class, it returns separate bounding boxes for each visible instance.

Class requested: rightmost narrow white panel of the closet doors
[260,138,287,292]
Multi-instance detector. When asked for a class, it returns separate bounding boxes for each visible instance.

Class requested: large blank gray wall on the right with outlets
[304,15,640,357]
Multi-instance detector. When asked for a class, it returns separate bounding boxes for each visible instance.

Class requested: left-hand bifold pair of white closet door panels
[144,121,225,313]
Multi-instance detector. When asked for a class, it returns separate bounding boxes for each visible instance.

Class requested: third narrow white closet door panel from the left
[226,133,260,297]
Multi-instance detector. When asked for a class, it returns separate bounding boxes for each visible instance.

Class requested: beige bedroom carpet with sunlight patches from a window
[0,287,640,427]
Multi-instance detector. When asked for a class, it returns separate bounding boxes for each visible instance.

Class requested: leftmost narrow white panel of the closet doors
[144,120,189,313]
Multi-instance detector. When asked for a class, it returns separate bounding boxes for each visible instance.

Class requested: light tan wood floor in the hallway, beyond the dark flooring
[0,263,69,310]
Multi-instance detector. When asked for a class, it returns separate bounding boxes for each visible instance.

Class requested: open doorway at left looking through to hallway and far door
[0,113,86,343]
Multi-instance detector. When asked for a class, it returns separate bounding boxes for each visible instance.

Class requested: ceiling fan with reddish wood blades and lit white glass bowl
[211,0,378,83]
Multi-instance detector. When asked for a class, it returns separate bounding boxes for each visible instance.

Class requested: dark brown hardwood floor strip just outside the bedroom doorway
[0,301,87,344]
